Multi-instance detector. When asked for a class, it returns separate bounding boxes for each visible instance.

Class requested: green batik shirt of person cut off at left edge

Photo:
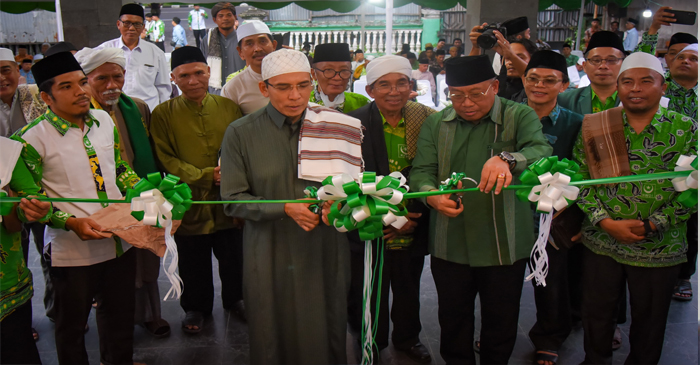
[0,151,51,321]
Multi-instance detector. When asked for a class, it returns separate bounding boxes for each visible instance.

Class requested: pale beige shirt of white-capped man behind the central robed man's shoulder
[221,67,270,115]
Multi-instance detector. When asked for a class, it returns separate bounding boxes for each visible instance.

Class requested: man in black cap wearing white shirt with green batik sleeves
[12,52,139,364]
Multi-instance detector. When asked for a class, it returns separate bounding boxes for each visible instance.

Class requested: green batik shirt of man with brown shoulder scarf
[574,107,698,267]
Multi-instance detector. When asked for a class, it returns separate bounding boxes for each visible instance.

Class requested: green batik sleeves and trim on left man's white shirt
[12,109,140,229]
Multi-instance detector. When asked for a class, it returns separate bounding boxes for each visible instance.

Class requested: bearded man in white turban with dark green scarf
[75,48,170,336]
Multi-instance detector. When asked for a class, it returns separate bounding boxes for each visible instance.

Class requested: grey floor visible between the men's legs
[24,245,698,365]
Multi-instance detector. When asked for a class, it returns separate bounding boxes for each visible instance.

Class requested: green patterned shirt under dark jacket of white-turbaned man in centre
[379,112,413,249]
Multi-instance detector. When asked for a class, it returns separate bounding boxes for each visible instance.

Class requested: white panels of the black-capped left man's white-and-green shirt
[22,110,131,267]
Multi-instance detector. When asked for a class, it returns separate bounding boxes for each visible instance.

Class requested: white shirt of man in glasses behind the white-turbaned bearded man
[97,37,172,111]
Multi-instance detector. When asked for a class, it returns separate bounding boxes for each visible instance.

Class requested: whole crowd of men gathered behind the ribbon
[0,3,698,365]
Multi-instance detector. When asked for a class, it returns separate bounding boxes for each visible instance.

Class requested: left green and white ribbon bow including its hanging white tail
[126,172,192,300]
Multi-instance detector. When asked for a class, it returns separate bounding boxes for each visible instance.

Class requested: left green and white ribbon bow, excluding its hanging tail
[126,172,192,228]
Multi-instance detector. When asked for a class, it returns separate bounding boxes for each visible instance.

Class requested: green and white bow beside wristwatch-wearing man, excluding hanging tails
[515,156,583,213]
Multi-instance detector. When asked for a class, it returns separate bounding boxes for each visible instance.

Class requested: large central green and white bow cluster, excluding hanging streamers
[317,172,408,241]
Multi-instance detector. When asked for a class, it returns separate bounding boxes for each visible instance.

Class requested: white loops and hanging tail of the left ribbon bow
[131,189,184,300]
